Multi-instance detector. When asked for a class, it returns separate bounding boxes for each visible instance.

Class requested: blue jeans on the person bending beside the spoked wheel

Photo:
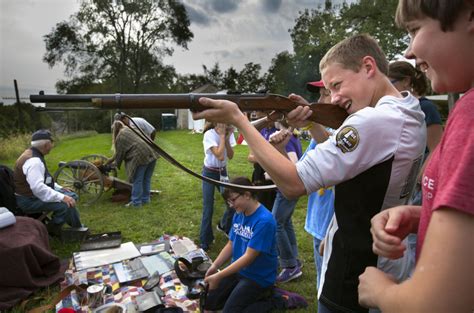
[130,160,156,206]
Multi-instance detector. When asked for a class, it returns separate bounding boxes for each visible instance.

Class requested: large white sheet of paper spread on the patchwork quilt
[73,241,140,271]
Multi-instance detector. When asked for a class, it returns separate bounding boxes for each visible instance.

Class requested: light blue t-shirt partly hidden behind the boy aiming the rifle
[301,139,334,240]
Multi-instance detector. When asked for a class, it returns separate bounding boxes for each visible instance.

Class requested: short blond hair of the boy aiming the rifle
[319,34,388,75]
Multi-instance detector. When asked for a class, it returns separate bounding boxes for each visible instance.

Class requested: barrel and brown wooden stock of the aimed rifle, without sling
[30,93,347,129]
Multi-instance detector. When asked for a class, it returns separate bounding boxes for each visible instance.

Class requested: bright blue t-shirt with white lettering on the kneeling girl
[230,205,278,288]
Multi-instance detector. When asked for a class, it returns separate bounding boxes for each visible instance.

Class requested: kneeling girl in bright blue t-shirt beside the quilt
[205,177,278,313]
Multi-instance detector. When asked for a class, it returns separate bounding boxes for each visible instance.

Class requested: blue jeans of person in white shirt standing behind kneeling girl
[199,167,234,246]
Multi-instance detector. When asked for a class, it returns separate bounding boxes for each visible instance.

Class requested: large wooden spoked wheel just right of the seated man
[54,160,104,204]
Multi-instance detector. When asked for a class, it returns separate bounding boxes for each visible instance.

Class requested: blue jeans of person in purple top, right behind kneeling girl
[272,192,298,268]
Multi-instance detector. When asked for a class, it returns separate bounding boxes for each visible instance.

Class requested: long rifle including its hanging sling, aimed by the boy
[30,93,347,191]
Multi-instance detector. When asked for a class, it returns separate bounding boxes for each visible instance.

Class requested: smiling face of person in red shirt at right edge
[405,10,474,93]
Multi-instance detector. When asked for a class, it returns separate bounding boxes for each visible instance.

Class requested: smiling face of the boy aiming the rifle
[322,63,372,114]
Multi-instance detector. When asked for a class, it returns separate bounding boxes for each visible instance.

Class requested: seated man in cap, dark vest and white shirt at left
[13,129,85,235]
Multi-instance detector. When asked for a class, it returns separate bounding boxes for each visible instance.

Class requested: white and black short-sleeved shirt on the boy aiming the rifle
[296,93,426,311]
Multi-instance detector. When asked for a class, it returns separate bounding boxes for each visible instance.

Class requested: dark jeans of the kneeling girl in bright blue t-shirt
[205,274,273,313]
